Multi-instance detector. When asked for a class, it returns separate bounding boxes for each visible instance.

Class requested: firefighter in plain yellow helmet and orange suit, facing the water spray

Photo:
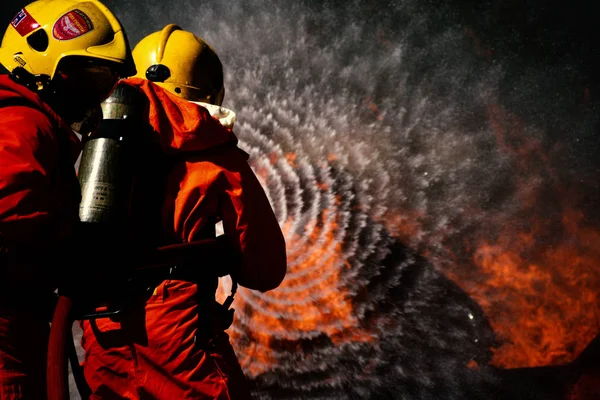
[81,24,287,400]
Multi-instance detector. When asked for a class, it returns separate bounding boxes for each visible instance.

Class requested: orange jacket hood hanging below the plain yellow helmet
[121,78,237,153]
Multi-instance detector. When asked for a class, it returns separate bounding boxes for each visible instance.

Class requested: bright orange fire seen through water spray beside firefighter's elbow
[219,209,371,376]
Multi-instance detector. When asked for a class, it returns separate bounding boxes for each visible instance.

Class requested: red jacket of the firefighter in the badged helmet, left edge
[0,75,81,253]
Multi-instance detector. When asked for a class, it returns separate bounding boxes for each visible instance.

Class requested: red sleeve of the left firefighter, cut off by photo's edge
[0,106,74,245]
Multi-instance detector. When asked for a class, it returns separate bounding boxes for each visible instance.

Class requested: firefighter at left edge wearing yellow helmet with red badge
[0,0,135,400]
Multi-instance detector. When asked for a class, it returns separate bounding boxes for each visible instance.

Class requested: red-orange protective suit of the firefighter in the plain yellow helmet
[82,78,286,400]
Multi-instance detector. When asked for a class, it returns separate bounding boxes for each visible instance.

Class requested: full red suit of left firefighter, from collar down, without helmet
[0,75,80,400]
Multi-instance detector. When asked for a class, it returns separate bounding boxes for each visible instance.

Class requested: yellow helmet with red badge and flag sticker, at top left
[0,0,136,79]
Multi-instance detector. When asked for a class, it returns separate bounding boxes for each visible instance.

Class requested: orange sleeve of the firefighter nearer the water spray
[175,146,287,292]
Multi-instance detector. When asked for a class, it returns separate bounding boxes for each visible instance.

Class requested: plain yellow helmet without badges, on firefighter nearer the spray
[133,24,225,106]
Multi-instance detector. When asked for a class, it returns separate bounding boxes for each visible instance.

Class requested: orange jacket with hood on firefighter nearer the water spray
[124,78,286,292]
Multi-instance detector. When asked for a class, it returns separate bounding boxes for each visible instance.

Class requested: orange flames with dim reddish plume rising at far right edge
[449,106,600,368]
